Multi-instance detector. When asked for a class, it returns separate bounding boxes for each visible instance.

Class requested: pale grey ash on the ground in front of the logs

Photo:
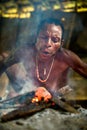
[0,107,87,130]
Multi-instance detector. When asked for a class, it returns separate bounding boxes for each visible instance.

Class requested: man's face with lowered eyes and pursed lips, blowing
[36,24,62,58]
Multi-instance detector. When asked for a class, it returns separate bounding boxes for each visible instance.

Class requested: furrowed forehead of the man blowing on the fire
[40,23,62,33]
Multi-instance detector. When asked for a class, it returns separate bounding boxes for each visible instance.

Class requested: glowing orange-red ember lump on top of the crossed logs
[32,87,52,102]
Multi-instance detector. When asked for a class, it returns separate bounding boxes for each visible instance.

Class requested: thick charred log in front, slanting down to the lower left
[1,103,52,122]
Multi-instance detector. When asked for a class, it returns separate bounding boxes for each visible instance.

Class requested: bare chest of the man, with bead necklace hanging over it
[26,58,68,89]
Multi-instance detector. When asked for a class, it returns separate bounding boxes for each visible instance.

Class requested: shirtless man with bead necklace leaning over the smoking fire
[1,19,87,100]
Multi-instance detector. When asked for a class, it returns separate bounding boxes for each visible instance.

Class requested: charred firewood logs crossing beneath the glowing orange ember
[1,90,79,122]
